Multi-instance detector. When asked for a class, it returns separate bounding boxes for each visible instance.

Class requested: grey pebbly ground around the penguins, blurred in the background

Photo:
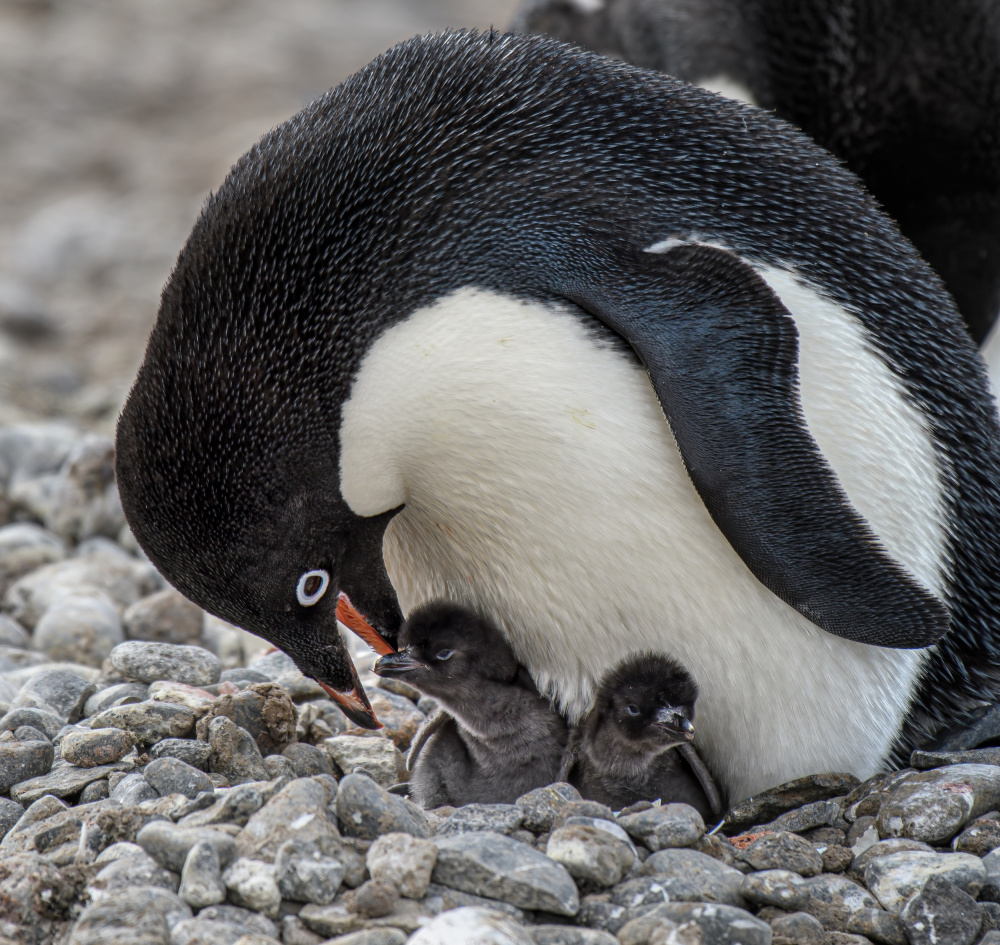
[0,0,1000,945]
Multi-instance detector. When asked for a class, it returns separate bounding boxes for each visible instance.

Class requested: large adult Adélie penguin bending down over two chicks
[111,32,1000,803]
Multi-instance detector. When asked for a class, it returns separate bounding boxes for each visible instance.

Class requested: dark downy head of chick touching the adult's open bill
[375,601,518,710]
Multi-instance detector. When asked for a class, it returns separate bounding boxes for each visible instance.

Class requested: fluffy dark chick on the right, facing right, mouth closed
[561,653,722,820]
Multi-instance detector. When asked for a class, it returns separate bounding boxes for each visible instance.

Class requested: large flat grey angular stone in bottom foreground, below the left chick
[432,832,580,915]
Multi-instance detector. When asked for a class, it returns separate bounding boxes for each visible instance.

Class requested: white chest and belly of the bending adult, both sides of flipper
[341,288,945,801]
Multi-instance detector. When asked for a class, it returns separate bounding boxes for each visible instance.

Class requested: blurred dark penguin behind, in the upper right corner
[513,0,1000,346]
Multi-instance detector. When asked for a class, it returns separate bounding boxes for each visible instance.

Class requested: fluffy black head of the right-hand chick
[588,653,698,750]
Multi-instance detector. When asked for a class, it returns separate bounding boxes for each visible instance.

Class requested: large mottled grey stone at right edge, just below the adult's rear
[876,765,1000,843]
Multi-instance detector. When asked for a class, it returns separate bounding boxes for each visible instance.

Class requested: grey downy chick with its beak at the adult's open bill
[375,601,569,808]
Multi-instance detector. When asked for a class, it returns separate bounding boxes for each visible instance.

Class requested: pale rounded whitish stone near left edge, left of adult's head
[34,591,125,667]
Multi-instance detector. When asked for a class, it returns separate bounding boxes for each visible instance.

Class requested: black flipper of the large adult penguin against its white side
[568,244,949,648]
